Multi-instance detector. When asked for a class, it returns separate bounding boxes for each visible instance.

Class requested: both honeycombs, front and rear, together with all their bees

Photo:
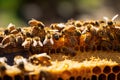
[0,15,120,80]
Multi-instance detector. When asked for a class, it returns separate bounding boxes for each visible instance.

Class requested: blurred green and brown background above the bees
[0,0,120,27]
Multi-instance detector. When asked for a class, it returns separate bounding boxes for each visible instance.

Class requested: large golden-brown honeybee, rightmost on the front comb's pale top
[29,53,51,66]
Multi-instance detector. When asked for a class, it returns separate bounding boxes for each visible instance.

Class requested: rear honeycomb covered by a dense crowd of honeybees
[0,15,120,56]
